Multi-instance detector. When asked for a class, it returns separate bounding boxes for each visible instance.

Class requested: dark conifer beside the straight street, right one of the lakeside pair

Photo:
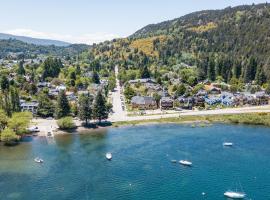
[93,91,109,122]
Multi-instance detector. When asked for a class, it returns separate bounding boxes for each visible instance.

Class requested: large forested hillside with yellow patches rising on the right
[85,4,270,85]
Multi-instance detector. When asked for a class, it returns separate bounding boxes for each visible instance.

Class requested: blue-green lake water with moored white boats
[0,124,270,200]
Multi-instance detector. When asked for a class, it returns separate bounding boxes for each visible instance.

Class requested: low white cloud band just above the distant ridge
[0,29,119,44]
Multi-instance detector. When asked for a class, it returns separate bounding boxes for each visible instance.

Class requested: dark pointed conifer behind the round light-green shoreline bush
[56,90,70,119]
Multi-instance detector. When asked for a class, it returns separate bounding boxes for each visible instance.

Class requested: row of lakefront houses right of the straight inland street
[129,79,270,110]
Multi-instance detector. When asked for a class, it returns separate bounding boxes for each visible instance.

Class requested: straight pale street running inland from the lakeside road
[109,66,127,121]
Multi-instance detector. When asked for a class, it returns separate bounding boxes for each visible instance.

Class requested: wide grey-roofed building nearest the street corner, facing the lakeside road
[131,96,157,110]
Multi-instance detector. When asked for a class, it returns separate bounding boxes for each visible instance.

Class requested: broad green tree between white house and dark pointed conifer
[37,92,55,117]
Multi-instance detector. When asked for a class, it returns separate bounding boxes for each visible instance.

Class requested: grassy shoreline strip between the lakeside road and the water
[32,112,270,137]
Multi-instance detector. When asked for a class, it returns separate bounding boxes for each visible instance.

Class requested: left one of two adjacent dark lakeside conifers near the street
[79,94,92,125]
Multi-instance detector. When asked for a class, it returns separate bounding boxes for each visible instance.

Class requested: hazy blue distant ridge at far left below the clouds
[0,33,70,47]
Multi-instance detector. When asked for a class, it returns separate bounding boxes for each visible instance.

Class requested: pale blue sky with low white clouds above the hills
[0,0,266,44]
